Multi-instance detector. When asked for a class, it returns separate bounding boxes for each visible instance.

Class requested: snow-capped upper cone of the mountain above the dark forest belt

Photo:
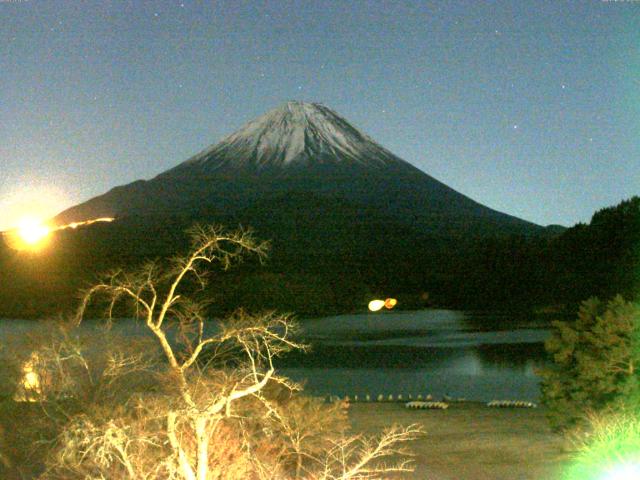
[54,102,544,236]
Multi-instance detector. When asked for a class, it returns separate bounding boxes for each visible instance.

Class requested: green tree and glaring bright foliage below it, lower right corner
[541,295,640,480]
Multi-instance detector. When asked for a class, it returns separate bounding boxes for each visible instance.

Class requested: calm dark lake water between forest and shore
[0,310,549,401]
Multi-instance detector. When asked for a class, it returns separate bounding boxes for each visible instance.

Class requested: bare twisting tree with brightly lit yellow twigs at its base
[35,226,420,480]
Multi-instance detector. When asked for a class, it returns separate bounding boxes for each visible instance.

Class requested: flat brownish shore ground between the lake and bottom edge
[349,402,566,480]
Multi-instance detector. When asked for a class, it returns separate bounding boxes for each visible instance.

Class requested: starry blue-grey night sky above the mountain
[0,0,640,229]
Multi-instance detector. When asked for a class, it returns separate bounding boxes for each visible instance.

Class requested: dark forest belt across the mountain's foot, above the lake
[0,197,640,318]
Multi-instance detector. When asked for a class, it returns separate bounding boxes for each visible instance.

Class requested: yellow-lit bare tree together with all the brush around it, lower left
[0,227,421,480]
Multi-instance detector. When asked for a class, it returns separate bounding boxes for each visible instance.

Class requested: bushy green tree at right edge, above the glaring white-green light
[541,295,640,429]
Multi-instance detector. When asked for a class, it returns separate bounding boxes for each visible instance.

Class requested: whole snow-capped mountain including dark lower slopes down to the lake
[0,102,558,318]
